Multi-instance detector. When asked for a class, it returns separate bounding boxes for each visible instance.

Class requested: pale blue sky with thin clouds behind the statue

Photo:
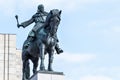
[0,0,120,80]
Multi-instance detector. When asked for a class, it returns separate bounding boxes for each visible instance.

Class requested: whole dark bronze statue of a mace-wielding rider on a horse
[16,5,63,80]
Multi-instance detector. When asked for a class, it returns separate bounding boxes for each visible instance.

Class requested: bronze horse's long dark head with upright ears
[48,9,61,35]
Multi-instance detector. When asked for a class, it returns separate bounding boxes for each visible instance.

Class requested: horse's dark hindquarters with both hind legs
[22,40,39,80]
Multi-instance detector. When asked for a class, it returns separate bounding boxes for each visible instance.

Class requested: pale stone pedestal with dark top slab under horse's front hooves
[29,71,64,80]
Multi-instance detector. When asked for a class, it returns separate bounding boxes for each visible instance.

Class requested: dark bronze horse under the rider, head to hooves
[22,9,61,80]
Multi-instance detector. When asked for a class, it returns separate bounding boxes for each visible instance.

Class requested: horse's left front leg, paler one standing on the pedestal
[39,44,45,71]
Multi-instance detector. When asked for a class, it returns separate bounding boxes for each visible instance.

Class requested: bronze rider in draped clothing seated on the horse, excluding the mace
[18,4,63,54]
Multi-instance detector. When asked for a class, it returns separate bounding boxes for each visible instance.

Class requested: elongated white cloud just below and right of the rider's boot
[55,52,96,63]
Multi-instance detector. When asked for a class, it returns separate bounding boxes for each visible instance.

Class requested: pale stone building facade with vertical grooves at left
[0,34,22,80]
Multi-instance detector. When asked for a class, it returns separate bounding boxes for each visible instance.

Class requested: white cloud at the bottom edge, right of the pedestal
[80,76,112,80]
